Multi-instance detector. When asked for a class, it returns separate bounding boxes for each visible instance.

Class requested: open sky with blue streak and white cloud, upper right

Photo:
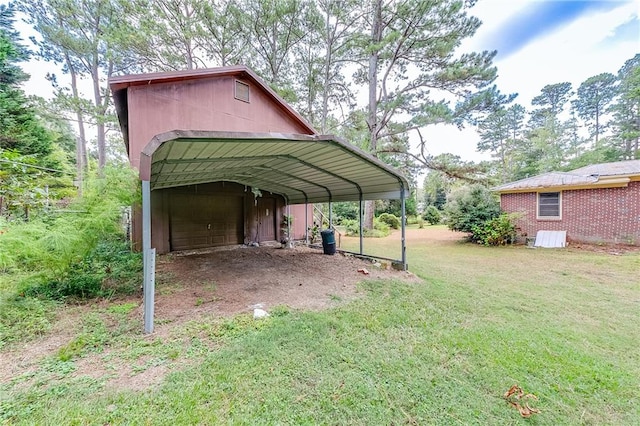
[420,0,640,161]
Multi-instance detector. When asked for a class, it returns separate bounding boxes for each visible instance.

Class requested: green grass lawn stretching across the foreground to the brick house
[0,227,640,425]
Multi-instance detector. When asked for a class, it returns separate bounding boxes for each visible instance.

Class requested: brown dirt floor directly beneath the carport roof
[156,246,415,322]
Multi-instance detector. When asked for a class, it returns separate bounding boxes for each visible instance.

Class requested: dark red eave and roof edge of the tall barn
[109,65,318,153]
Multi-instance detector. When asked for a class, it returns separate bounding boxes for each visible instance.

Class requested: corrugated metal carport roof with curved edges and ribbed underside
[140,130,409,204]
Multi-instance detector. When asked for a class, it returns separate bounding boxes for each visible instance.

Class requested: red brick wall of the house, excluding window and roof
[500,182,640,245]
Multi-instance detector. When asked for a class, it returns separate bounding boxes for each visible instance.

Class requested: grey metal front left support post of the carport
[142,180,156,334]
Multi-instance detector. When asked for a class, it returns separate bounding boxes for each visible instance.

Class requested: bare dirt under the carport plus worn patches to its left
[0,246,420,390]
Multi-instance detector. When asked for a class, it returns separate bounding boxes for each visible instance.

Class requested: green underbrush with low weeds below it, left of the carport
[0,168,142,347]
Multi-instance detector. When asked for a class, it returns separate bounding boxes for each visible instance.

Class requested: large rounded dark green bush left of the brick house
[444,184,500,233]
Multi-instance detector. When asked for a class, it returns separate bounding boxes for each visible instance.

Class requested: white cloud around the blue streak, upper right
[420,0,640,165]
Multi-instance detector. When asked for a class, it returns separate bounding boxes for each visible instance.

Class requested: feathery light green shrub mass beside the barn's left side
[0,167,141,299]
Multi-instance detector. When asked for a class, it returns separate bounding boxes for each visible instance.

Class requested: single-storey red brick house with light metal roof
[493,160,640,245]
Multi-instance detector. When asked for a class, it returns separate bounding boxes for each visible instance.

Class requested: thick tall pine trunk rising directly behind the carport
[364,0,382,229]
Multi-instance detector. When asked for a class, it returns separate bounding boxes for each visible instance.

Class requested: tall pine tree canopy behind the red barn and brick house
[0,0,640,222]
